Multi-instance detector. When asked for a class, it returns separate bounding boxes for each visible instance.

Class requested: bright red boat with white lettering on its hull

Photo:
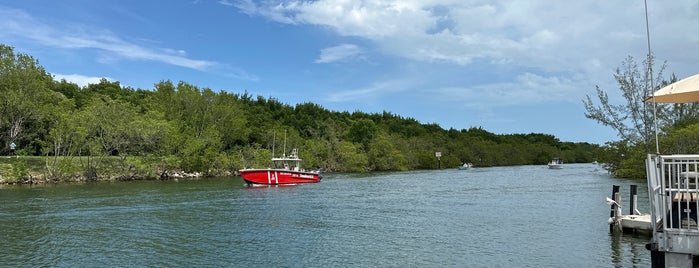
[239,149,322,185]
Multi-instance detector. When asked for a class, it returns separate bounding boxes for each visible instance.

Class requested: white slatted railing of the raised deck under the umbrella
[646,154,699,255]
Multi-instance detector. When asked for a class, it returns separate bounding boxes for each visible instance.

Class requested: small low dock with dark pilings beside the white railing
[607,185,653,235]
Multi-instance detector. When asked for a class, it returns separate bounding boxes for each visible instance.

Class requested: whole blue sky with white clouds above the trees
[0,0,699,144]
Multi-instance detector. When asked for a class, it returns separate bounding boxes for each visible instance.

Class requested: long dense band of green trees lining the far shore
[0,46,598,182]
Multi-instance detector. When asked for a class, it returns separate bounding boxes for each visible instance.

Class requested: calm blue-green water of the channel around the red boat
[0,164,650,267]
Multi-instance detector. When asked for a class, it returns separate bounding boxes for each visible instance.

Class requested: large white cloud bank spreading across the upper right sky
[235,0,699,75]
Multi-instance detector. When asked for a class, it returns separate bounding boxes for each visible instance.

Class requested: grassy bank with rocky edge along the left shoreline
[0,156,227,184]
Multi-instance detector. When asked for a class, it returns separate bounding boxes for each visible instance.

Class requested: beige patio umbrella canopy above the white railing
[645,74,699,103]
